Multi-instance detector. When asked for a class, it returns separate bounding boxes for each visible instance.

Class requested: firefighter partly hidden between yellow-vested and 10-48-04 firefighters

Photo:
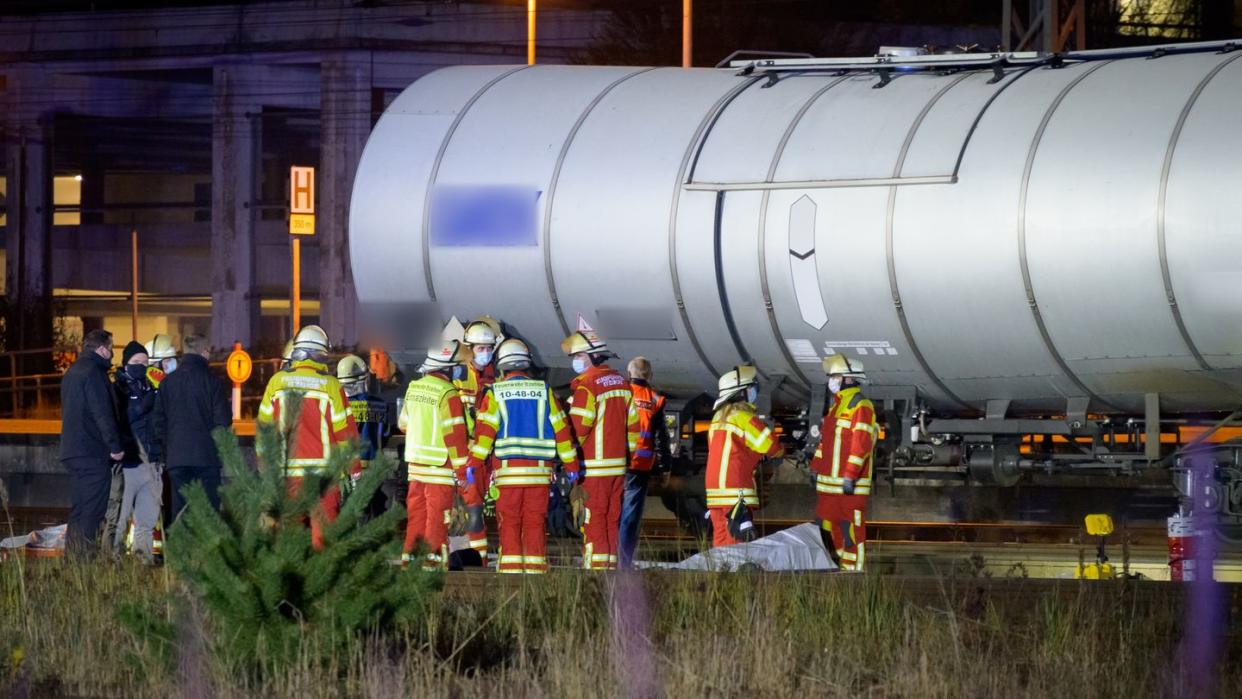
[453,315,503,566]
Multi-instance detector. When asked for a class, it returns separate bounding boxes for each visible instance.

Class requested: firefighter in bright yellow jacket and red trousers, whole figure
[397,340,473,569]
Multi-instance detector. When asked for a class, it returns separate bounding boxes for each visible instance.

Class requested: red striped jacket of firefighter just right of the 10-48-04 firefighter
[569,365,638,478]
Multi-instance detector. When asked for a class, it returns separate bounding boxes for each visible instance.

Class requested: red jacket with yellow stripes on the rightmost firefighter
[811,386,879,495]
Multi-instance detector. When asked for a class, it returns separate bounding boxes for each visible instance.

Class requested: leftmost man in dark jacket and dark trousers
[61,329,124,557]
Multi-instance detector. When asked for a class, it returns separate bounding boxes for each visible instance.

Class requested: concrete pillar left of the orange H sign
[211,65,260,350]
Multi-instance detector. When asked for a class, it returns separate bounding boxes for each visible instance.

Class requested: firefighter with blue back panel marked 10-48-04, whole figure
[468,338,579,574]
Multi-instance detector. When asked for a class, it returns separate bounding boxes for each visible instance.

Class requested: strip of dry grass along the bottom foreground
[0,561,1242,699]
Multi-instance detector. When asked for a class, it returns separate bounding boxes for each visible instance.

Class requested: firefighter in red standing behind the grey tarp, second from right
[704,366,782,546]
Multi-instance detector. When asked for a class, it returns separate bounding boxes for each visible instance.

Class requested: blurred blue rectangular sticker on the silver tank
[430,185,542,247]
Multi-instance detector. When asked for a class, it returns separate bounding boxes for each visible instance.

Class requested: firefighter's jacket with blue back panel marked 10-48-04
[469,371,579,488]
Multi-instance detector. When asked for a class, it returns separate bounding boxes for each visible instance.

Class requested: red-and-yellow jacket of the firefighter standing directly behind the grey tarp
[704,402,782,508]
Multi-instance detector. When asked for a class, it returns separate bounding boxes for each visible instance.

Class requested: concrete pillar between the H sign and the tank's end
[315,51,371,346]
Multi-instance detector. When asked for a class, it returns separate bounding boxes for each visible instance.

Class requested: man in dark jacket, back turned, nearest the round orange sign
[153,335,232,524]
